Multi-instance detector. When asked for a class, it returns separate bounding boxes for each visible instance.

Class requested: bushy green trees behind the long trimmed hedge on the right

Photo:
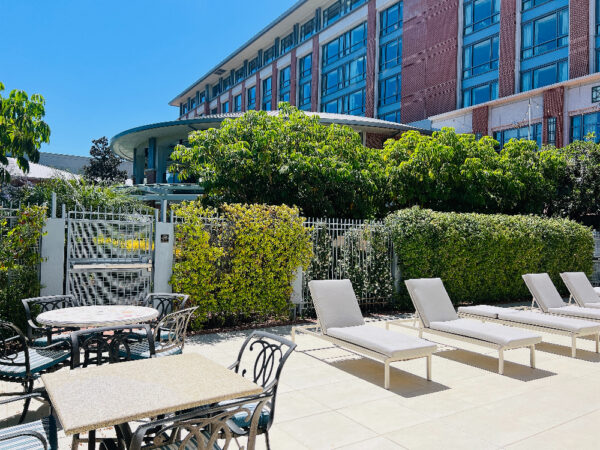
[384,128,564,214]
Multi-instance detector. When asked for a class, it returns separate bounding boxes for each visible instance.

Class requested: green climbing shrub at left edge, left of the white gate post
[0,206,46,330]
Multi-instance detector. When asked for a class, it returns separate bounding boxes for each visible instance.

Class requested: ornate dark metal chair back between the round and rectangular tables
[71,324,154,369]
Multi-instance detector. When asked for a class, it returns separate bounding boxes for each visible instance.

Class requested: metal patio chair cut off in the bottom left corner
[0,392,58,450]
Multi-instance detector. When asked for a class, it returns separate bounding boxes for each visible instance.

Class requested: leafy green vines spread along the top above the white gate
[0,178,151,212]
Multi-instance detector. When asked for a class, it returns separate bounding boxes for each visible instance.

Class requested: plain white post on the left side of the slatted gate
[40,213,66,295]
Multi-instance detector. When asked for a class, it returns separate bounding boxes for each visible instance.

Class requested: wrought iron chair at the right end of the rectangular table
[224,331,296,449]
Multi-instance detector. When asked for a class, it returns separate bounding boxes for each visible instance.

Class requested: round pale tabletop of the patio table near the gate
[36,305,158,328]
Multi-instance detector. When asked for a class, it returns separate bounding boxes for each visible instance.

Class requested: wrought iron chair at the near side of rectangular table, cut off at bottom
[129,393,271,450]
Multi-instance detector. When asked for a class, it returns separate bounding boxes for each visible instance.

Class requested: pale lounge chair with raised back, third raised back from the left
[523,273,600,322]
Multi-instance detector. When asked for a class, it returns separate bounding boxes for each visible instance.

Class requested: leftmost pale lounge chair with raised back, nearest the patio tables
[292,280,437,389]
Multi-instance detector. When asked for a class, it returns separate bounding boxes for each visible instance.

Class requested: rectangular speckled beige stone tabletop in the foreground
[42,353,262,434]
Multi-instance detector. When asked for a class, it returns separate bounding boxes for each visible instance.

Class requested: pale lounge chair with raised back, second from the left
[387,278,542,374]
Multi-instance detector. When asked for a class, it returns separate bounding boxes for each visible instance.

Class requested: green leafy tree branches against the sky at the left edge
[0,83,50,181]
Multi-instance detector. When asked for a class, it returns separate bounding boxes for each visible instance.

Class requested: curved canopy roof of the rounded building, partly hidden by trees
[110,111,431,161]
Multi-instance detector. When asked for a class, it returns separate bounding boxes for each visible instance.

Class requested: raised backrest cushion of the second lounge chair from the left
[405,278,458,327]
